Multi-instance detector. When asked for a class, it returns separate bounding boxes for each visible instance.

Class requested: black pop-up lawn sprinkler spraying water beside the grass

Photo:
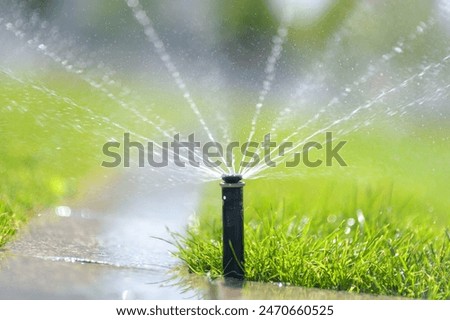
[220,174,245,279]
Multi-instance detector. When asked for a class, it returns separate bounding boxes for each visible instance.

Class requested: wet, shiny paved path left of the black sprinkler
[0,171,198,299]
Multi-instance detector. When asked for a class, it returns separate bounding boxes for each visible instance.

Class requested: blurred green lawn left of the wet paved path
[0,74,116,247]
